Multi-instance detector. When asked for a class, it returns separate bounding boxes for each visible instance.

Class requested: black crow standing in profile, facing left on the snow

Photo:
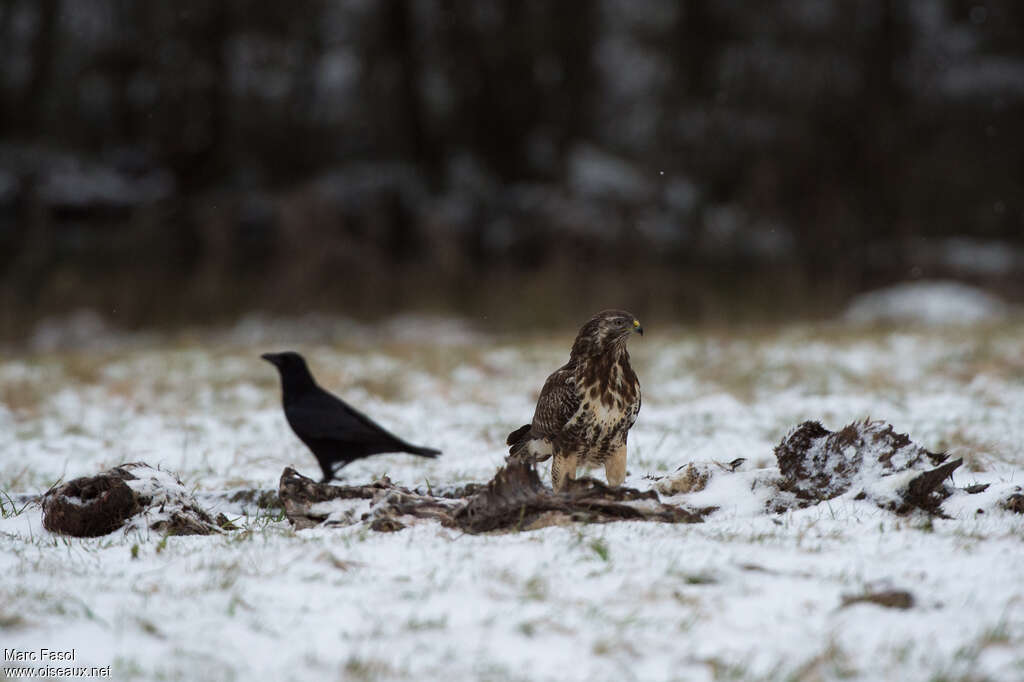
[260,351,441,483]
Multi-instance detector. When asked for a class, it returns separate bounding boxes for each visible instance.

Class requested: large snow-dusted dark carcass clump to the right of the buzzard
[775,420,964,513]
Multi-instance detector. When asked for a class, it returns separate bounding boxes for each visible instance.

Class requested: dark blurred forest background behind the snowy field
[0,0,1024,336]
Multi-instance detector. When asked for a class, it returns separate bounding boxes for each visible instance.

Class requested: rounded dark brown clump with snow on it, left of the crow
[41,462,226,538]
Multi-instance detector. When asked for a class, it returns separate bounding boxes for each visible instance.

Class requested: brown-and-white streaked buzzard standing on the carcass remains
[506,310,643,491]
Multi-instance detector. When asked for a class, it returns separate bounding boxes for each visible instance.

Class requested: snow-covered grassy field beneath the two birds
[0,318,1024,680]
